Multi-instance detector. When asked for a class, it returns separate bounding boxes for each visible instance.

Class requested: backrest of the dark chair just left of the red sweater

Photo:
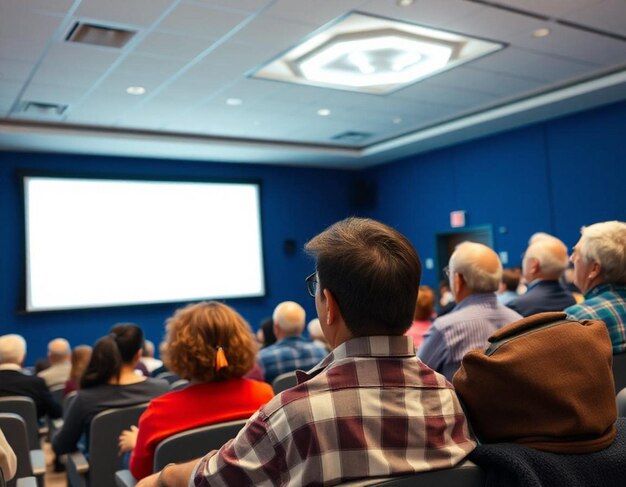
[89,403,148,487]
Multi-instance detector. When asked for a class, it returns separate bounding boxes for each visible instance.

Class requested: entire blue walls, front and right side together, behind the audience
[0,102,626,363]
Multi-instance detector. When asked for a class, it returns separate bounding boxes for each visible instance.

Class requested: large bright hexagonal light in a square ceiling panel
[254,13,504,94]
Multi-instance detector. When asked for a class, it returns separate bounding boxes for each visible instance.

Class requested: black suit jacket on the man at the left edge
[0,370,61,418]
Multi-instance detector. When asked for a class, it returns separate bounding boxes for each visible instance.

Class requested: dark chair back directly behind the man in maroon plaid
[341,460,485,487]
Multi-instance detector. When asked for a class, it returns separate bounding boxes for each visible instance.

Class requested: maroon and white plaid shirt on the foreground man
[190,336,475,487]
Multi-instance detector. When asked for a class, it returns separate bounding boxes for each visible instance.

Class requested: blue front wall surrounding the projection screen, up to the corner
[0,153,354,364]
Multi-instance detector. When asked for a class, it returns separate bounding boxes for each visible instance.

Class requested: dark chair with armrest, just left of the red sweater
[66,403,148,487]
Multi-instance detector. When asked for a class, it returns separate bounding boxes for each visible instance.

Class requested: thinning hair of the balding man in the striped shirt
[450,242,502,293]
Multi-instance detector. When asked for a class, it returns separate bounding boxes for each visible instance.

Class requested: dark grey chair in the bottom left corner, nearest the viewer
[0,413,46,487]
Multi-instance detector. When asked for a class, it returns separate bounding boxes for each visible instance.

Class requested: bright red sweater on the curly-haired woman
[130,379,274,480]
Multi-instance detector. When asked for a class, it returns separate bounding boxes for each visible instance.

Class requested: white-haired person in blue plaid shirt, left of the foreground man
[257,301,326,384]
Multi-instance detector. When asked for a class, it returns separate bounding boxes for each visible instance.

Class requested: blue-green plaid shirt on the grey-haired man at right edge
[565,284,626,353]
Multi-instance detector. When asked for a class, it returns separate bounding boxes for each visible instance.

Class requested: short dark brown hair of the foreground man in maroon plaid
[305,218,422,337]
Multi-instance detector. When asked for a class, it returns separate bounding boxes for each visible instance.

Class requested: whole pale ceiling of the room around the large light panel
[0,0,626,167]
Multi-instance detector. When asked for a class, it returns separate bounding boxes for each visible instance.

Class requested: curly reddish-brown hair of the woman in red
[164,301,257,382]
